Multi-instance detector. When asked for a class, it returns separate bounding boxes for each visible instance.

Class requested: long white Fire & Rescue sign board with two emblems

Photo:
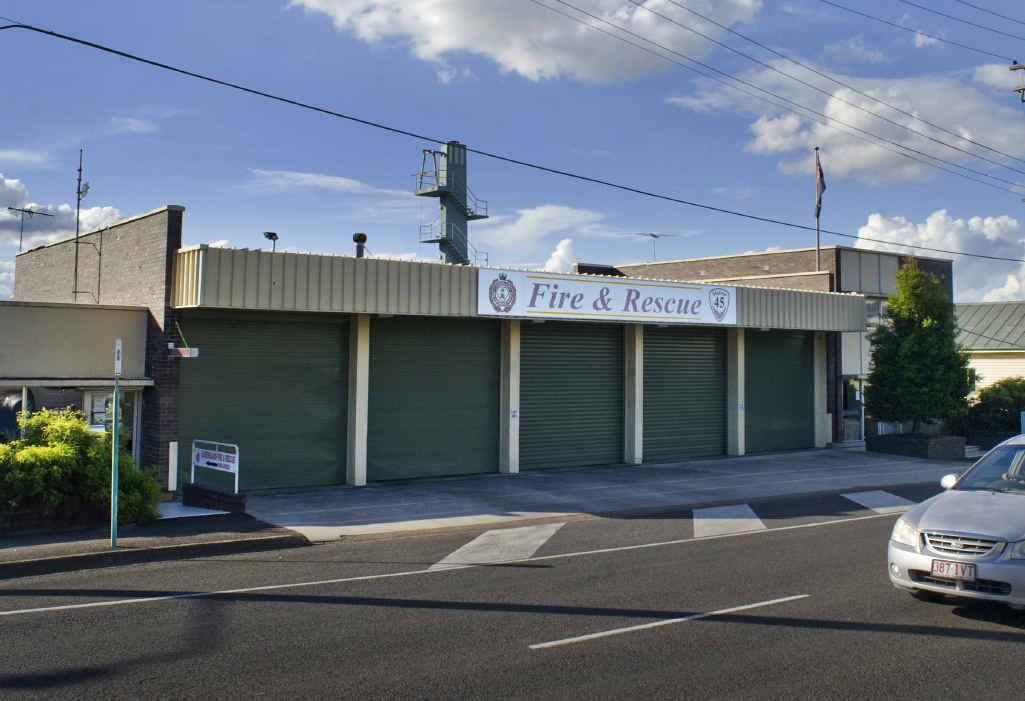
[477,269,737,325]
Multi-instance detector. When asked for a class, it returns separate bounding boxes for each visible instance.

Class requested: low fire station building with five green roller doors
[14,211,865,490]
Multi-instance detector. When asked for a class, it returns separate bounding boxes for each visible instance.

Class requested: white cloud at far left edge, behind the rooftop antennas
[0,173,121,248]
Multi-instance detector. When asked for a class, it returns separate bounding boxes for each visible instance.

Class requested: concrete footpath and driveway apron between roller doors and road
[0,448,970,578]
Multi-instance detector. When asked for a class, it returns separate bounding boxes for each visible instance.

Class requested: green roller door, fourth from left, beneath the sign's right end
[644,326,726,462]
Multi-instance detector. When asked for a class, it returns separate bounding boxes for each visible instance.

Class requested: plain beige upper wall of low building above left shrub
[0,301,149,381]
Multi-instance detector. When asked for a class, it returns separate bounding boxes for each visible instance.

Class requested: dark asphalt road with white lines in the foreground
[0,489,1025,699]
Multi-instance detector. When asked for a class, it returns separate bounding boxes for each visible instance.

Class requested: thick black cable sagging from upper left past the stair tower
[0,25,1025,262]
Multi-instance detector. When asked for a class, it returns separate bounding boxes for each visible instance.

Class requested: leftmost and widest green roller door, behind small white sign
[174,314,349,490]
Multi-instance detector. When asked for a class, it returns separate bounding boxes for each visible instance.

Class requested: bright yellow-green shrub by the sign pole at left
[0,409,160,523]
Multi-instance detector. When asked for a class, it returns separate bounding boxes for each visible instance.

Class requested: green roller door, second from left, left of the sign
[367,317,501,481]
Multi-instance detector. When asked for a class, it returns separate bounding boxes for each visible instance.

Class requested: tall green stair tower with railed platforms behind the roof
[413,141,488,265]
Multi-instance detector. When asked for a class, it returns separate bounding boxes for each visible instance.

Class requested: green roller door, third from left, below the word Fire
[520,322,623,469]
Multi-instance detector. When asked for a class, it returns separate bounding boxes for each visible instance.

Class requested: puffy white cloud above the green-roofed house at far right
[855,209,1025,301]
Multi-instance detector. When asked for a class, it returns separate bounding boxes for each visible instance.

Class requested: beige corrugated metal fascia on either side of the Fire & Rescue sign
[172,246,865,331]
